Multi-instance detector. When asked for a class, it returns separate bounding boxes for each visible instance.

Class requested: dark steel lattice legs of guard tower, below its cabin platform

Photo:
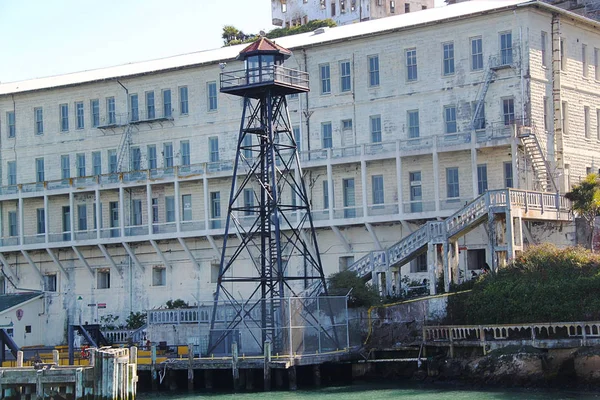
[209,87,326,352]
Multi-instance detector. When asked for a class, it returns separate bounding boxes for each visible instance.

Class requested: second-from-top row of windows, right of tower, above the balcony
[321,97,515,149]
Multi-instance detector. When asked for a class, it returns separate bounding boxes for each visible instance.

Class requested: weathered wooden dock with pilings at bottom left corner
[0,347,137,400]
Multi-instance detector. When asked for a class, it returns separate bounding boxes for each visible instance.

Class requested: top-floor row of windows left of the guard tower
[6,82,218,138]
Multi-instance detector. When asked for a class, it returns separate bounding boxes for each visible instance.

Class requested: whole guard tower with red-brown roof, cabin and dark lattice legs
[209,37,326,354]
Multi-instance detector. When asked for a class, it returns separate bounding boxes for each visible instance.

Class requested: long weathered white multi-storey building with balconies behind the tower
[0,1,600,351]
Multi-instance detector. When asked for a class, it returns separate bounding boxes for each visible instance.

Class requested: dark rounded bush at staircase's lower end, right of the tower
[327,271,381,308]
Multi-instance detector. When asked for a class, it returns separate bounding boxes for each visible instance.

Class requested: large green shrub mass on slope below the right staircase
[447,244,600,324]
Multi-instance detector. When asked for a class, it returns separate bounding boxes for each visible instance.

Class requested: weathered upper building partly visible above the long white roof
[271,0,434,28]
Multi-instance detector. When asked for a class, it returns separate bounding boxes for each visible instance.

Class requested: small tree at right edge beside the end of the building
[565,174,600,249]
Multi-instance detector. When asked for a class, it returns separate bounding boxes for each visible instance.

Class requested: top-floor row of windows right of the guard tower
[319,32,513,94]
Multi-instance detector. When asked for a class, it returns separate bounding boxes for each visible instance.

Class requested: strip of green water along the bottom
[137,384,600,400]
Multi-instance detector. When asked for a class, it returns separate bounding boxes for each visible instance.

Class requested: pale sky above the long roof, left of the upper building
[0,0,274,83]
